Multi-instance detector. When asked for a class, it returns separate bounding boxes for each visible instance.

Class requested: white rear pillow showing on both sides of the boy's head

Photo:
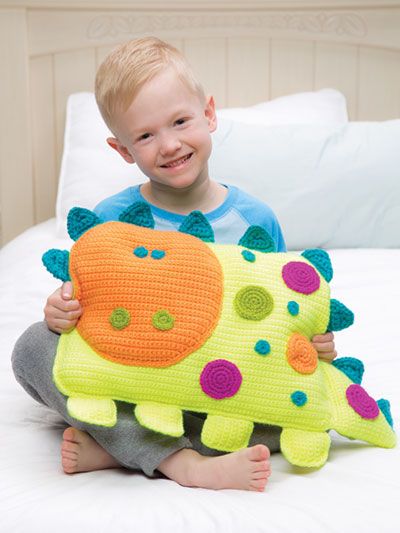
[56,89,347,236]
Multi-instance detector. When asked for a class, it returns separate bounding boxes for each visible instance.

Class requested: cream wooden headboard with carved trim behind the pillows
[0,0,400,243]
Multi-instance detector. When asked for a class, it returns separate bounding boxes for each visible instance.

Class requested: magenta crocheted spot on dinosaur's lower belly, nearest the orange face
[200,359,242,400]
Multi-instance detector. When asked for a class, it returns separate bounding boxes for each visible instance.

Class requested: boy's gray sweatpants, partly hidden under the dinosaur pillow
[12,322,281,476]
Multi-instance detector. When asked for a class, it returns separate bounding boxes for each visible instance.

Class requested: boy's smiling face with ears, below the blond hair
[107,68,216,189]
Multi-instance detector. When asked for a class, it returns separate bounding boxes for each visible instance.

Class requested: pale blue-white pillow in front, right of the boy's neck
[210,119,400,250]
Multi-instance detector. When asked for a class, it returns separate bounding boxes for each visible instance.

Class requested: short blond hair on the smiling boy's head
[95,37,205,130]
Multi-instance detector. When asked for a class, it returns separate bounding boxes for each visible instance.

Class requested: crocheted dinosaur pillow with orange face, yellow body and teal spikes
[43,202,396,467]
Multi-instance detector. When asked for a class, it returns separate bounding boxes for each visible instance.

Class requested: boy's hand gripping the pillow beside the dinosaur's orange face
[43,281,82,333]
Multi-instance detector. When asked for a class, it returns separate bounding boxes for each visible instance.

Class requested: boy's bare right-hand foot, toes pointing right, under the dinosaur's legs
[158,444,271,492]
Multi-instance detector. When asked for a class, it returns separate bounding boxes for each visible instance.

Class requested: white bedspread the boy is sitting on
[0,219,400,533]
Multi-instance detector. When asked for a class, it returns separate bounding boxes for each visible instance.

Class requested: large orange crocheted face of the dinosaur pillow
[70,222,223,367]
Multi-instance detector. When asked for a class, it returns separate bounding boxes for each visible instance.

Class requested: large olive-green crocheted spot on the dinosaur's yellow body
[233,285,274,320]
